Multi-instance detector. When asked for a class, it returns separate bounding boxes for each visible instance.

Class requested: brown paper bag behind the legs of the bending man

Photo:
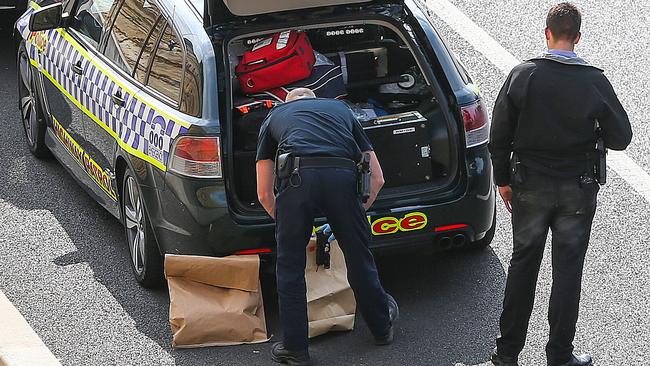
[305,237,357,338]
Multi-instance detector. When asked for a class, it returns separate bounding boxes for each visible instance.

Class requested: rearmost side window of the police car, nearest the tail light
[148,24,184,103]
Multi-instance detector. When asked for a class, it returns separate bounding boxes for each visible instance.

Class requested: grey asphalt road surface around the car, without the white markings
[0,0,650,366]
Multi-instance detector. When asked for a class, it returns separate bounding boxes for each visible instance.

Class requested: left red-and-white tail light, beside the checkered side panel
[169,136,223,178]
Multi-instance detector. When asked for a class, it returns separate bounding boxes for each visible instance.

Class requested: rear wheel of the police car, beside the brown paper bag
[120,168,164,288]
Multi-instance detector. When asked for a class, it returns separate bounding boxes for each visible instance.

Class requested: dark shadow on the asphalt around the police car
[0,25,505,365]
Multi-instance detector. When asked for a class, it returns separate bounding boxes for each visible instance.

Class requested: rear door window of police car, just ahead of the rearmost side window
[104,0,160,74]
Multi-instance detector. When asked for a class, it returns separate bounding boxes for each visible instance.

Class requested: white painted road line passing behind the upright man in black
[426,0,650,202]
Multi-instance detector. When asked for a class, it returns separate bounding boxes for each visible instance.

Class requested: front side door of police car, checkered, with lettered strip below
[41,0,123,210]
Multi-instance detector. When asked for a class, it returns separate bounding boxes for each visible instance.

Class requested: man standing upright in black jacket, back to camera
[489,3,632,366]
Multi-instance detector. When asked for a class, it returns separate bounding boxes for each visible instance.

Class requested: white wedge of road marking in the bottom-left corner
[0,291,61,366]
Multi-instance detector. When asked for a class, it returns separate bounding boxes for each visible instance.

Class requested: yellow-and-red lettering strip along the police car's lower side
[52,117,117,201]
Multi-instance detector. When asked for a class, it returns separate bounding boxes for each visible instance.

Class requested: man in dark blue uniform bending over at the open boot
[257,88,398,365]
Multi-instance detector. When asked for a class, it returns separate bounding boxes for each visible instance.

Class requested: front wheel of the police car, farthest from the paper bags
[17,42,51,159]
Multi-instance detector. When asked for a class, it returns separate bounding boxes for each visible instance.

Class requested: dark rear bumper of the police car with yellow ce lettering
[143,146,495,256]
